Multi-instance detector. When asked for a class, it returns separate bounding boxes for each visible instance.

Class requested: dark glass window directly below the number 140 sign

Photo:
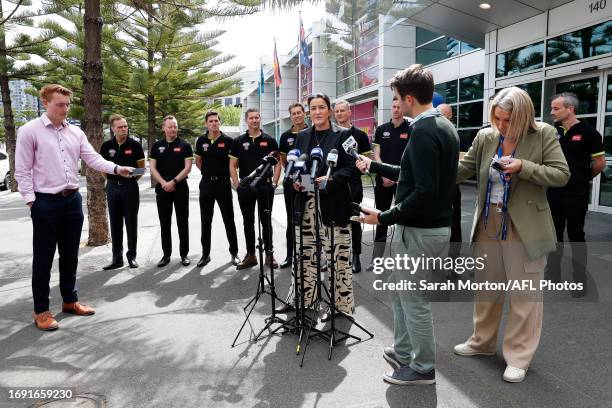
[546,21,612,65]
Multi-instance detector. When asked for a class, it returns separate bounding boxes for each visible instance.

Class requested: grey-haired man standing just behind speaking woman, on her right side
[334,100,372,273]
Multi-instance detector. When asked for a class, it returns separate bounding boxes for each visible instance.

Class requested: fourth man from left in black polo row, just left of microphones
[229,108,281,269]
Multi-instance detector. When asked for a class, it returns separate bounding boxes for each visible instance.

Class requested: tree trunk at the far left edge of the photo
[0,1,17,192]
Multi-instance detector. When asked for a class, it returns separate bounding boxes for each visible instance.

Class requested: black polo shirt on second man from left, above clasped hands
[149,137,193,181]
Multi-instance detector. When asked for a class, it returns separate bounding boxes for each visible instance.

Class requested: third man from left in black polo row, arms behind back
[195,111,240,268]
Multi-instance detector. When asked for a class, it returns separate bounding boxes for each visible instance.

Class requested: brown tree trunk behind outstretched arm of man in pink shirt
[83,0,108,246]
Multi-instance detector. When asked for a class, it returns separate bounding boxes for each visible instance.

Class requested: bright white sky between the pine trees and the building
[210,2,325,70]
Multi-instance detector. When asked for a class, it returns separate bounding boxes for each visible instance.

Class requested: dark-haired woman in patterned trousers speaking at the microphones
[277,93,357,322]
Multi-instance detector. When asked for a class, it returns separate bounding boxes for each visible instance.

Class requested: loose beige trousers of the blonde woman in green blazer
[468,205,546,369]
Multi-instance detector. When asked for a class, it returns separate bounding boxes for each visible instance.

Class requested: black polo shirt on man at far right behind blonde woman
[557,122,604,193]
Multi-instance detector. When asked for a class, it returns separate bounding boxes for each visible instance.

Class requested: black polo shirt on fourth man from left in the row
[230,132,278,179]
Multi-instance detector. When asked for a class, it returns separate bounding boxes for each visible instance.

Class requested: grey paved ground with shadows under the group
[0,174,612,408]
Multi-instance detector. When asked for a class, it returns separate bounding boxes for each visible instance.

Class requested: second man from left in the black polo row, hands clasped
[149,115,193,268]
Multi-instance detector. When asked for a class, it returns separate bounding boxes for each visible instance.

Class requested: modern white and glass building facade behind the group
[243,0,612,213]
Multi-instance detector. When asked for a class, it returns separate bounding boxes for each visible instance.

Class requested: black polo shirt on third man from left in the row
[195,132,234,179]
